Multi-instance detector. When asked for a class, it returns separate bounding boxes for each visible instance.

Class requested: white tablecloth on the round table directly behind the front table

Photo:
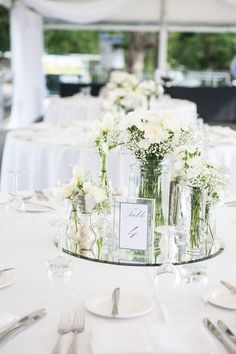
[1,122,236,194]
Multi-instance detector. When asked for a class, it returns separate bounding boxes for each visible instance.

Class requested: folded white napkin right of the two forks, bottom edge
[90,324,152,354]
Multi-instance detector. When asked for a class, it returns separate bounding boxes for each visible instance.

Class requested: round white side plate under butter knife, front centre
[85,291,153,318]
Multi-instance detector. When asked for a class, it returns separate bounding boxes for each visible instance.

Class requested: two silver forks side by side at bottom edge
[52,309,85,354]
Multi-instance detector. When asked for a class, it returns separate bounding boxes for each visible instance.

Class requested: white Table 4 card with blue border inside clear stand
[119,202,149,251]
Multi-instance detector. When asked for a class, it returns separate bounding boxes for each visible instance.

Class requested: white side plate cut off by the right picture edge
[205,285,236,310]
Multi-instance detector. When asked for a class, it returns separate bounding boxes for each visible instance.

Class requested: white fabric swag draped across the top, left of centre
[22,0,130,23]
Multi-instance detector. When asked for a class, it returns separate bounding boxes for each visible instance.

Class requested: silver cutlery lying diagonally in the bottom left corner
[0,309,46,345]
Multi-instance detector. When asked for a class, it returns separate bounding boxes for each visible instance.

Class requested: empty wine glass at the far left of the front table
[6,170,25,211]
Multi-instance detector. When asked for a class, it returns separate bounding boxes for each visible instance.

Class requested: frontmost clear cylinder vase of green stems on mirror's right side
[187,187,205,256]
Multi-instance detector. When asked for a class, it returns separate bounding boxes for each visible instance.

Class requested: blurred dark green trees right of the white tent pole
[168,33,236,70]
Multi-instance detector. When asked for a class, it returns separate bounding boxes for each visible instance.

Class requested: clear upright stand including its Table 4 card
[114,198,155,263]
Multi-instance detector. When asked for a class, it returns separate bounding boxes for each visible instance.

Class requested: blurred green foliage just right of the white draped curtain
[44,30,99,54]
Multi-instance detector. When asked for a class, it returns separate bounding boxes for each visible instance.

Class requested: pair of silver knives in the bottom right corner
[203,317,236,354]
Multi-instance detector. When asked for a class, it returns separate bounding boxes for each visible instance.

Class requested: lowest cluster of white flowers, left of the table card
[59,165,110,214]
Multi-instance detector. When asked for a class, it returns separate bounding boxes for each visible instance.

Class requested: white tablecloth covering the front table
[0,196,236,354]
